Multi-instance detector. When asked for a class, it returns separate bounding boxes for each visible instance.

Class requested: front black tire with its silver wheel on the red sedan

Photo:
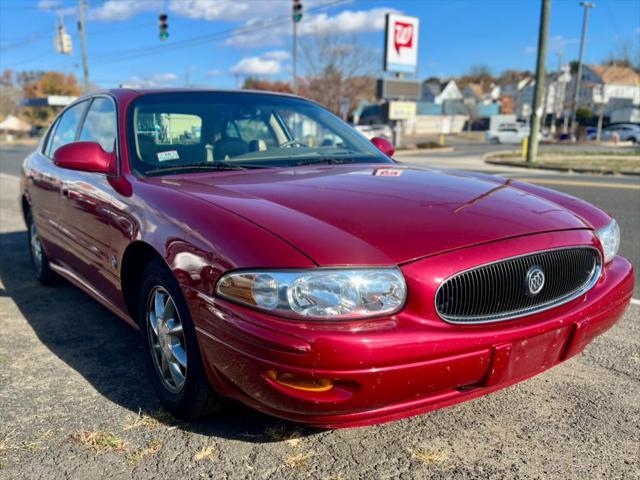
[138,259,223,420]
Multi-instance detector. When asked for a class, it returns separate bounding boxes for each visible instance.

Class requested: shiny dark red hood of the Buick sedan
[152,165,589,265]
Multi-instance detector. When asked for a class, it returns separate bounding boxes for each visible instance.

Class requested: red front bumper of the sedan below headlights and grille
[190,233,633,428]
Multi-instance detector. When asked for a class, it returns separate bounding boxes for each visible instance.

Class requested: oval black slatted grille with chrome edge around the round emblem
[436,247,601,324]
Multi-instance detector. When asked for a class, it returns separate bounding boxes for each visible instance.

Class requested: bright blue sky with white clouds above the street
[0,0,640,87]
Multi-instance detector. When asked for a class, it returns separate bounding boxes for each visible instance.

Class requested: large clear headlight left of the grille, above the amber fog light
[216,268,407,320]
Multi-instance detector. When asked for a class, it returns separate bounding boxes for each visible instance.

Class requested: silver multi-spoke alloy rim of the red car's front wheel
[146,286,187,393]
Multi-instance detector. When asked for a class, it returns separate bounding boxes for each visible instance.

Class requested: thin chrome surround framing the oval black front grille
[433,245,602,325]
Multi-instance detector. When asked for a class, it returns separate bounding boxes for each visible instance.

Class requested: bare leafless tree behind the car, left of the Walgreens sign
[298,33,377,114]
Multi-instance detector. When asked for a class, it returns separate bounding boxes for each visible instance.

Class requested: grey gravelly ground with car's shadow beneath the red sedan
[0,176,640,479]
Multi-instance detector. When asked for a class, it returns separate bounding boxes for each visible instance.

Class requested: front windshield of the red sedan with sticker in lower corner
[128,92,392,175]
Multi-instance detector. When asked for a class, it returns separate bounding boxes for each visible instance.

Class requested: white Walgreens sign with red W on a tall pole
[384,13,420,73]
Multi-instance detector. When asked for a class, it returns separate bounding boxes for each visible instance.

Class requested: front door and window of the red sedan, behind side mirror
[59,96,116,294]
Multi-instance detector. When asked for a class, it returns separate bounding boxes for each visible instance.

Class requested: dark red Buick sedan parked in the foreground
[21,89,633,428]
